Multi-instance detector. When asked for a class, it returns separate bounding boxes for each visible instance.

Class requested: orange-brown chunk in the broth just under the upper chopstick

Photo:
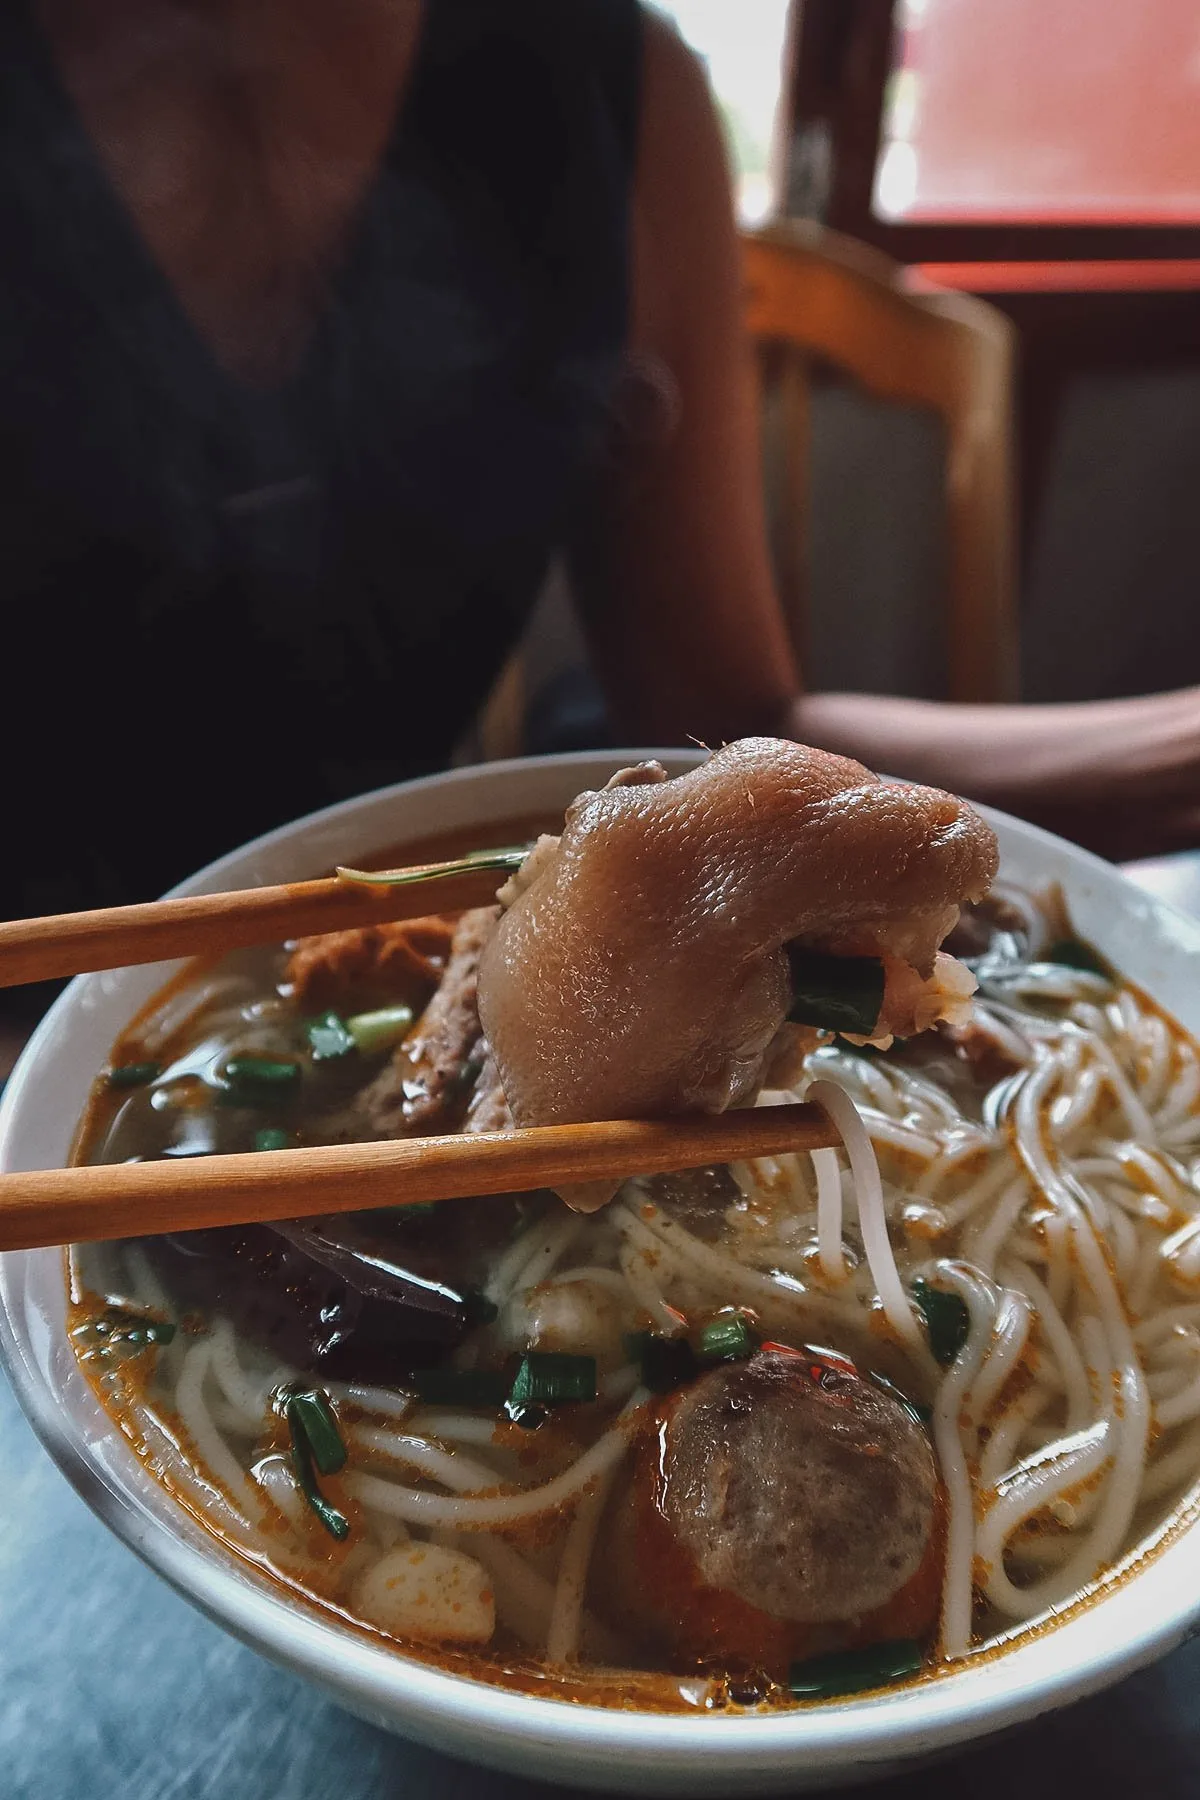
[284,914,453,1008]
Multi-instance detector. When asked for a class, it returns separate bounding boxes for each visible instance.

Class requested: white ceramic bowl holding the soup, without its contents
[0,752,1200,1795]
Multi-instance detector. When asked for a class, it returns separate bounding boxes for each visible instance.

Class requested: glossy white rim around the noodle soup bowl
[0,749,1200,1780]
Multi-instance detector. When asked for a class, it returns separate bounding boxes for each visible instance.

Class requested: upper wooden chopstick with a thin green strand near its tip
[0,851,516,988]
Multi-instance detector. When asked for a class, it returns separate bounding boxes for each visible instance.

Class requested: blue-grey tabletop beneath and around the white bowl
[0,859,1200,1800]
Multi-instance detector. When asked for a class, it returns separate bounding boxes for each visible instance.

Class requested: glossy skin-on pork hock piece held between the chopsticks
[479,738,997,1209]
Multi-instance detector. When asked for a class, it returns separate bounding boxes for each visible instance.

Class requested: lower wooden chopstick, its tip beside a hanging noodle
[0,1103,840,1249]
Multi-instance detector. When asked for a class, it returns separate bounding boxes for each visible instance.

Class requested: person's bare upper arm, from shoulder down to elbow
[572,13,799,743]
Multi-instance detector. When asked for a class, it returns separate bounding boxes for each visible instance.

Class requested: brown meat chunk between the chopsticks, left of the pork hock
[356,905,511,1138]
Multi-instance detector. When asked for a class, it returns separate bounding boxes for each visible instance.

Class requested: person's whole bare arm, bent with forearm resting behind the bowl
[578,16,1200,848]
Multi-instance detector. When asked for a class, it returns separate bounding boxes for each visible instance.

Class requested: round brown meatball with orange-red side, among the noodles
[613,1348,943,1676]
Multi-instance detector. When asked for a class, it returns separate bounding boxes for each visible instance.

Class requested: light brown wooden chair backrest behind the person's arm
[745,221,1016,700]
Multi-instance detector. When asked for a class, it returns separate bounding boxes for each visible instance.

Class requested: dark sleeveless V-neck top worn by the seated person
[0,0,640,916]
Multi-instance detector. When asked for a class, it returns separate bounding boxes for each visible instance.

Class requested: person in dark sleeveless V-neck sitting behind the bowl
[0,0,1200,957]
